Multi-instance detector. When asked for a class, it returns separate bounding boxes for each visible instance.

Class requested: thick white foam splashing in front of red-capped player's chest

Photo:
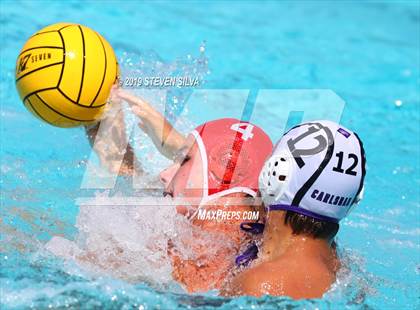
[46,199,177,288]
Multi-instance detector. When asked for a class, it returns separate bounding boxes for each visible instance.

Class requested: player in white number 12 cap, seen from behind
[223,121,366,299]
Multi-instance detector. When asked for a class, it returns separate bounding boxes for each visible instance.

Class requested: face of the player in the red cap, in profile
[160,135,203,205]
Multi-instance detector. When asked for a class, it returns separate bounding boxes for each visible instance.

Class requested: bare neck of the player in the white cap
[261,211,331,261]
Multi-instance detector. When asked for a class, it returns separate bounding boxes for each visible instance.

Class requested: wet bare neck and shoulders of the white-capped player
[222,211,340,299]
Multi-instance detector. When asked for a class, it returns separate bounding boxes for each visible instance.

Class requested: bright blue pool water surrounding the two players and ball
[0,0,420,309]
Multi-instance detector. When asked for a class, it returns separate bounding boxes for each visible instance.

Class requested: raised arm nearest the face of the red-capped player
[115,89,186,159]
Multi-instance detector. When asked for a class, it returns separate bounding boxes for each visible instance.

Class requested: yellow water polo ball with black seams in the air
[16,23,118,127]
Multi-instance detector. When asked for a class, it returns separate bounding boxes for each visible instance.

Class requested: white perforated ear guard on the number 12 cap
[258,150,292,207]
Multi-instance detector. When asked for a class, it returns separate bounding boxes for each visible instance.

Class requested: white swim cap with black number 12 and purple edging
[259,121,366,223]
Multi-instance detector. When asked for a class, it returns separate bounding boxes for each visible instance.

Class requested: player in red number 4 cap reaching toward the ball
[107,90,273,292]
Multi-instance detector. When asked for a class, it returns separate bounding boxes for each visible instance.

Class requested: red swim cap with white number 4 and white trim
[192,118,273,201]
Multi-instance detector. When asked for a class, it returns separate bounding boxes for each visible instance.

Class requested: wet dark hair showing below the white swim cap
[284,211,339,239]
